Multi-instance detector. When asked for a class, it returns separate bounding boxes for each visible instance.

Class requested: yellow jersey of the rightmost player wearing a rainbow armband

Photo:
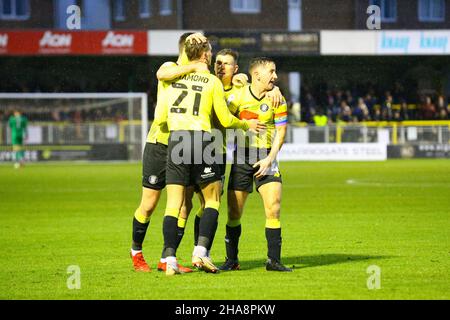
[230,85,287,149]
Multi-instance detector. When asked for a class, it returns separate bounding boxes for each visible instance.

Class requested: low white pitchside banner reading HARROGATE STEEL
[278,143,387,161]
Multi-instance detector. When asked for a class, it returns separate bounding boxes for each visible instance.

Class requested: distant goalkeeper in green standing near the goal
[8,109,28,169]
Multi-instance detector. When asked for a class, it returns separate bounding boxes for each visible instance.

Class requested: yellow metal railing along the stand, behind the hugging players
[0,120,450,146]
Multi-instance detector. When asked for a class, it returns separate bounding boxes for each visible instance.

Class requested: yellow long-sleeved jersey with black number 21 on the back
[155,72,249,132]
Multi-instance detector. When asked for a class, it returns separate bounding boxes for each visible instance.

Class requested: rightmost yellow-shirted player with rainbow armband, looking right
[220,58,292,271]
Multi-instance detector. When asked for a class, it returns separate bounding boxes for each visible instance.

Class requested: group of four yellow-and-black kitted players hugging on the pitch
[131,33,292,275]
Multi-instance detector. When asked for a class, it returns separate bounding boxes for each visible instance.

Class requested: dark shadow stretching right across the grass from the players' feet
[240,253,392,270]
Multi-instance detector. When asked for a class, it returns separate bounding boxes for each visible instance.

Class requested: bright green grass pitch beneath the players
[0,160,450,300]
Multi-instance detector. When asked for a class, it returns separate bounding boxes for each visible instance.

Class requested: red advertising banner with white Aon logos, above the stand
[0,30,148,55]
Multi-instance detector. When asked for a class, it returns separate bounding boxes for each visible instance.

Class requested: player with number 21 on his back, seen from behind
[156,42,261,275]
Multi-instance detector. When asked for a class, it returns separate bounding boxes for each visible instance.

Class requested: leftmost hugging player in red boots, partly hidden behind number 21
[131,33,207,272]
